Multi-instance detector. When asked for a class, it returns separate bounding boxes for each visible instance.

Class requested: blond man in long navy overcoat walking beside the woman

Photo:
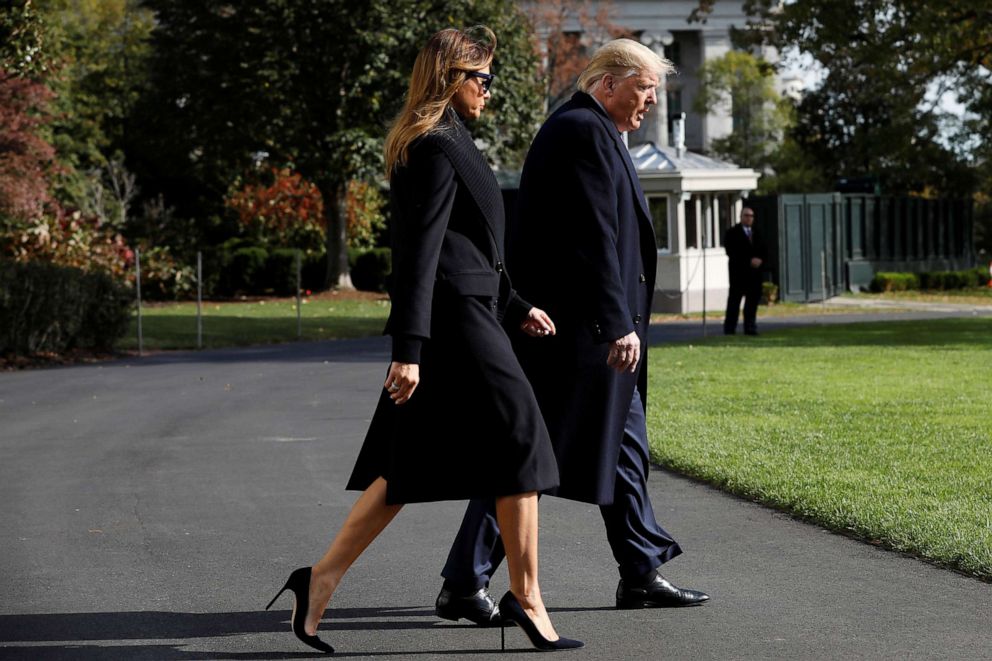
[436,39,709,625]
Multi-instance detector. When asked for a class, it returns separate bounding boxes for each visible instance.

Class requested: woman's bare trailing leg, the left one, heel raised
[303,477,404,636]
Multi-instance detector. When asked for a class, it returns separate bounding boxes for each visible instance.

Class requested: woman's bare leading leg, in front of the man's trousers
[496,491,558,640]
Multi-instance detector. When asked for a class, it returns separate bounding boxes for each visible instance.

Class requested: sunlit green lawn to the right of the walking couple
[648,318,992,580]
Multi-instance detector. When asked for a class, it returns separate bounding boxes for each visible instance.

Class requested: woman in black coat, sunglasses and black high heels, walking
[269,28,582,652]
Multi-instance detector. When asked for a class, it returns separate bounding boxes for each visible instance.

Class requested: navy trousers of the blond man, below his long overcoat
[441,390,682,593]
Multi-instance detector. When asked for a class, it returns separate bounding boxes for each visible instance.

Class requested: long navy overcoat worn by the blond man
[507,92,657,504]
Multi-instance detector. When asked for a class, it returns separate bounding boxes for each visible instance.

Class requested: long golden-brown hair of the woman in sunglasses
[385,26,496,177]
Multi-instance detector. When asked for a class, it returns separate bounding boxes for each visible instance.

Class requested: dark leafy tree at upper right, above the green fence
[696,0,992,194]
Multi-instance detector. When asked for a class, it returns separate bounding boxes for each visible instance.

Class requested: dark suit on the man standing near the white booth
[723,223,768,334]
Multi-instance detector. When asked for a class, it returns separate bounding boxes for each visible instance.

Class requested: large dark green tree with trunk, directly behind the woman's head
[131,0,540,285]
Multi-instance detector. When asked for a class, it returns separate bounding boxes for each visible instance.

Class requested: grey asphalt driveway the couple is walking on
[0,310,992,660]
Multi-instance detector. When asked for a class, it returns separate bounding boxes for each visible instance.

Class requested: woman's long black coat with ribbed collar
[348,111,558,503]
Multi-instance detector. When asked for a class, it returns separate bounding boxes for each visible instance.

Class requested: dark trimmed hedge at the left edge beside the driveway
[0,259,134,355]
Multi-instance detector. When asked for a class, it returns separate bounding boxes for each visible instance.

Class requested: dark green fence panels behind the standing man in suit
[748,193,975,302]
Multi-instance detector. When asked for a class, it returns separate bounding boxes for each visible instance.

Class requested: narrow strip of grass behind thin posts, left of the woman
[117,292,389,351]
